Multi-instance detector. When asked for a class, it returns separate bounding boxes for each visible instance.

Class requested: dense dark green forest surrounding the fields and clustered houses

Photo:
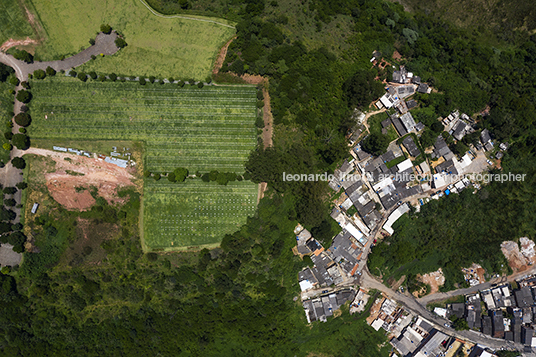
[0,0,536,357]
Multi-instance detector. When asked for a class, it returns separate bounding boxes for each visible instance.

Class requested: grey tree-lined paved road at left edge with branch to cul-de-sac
[0,32,119,266]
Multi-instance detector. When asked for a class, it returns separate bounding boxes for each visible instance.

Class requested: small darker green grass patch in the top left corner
[0,0,34,45]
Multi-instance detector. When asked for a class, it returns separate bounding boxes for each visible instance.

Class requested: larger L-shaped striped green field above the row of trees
[30,78,257,173]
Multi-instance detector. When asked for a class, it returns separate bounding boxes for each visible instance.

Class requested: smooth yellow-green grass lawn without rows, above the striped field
[27,0,235,80]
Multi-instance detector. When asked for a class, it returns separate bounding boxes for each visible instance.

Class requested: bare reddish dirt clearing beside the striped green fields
[25,148,135,211]
